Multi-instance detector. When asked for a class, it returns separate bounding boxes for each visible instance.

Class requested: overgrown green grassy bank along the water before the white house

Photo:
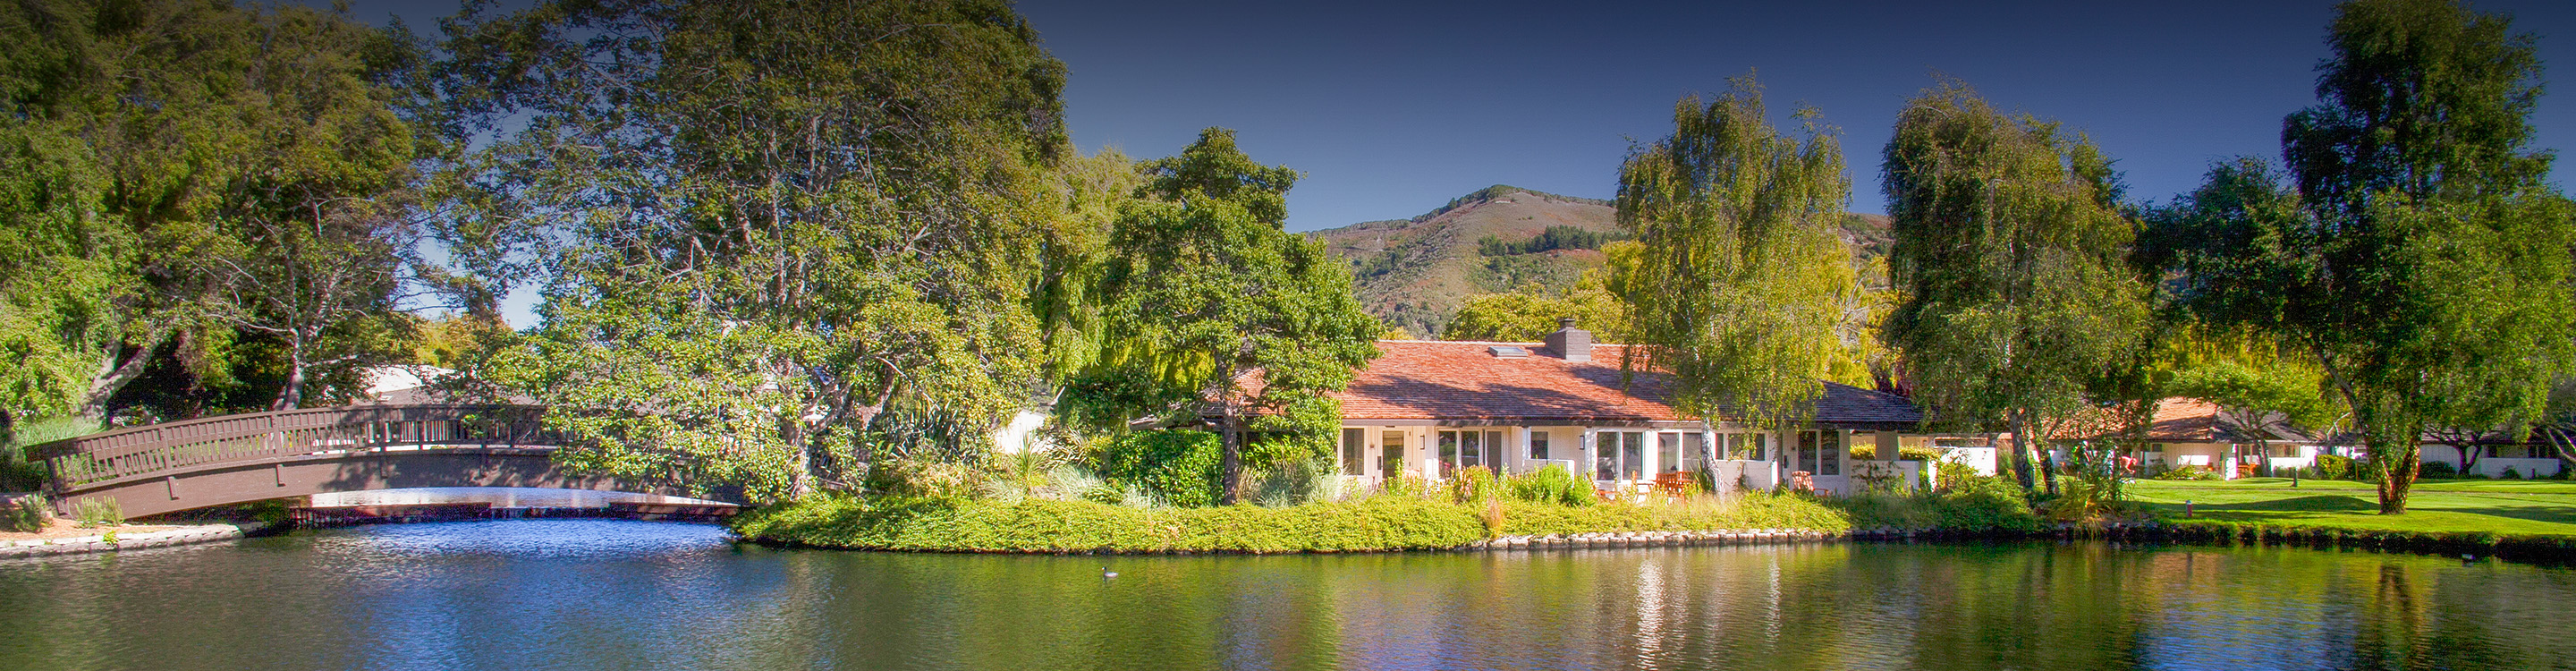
[726,485,2040,555]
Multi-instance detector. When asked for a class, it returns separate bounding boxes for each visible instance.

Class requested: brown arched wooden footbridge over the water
[29,405,716,516]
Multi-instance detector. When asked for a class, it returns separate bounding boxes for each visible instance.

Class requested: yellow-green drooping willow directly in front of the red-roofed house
[1618,75,1860,436]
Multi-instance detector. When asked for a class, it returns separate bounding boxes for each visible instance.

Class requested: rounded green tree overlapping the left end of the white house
[1082,129,1381,504]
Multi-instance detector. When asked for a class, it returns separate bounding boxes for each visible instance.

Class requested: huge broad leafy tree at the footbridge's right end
[440,0,1066,501]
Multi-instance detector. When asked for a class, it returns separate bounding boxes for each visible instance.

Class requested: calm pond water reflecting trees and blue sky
[0,519,2576,671]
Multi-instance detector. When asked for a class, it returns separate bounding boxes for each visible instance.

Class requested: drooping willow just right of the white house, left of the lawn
[1883,80,2148,485]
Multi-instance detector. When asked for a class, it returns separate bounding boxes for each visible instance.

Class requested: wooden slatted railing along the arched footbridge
[26,405,556,490]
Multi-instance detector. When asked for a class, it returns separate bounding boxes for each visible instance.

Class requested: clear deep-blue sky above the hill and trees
[337,0,2576,325]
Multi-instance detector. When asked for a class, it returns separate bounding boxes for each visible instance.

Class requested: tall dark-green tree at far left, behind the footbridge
[0,0,430,418]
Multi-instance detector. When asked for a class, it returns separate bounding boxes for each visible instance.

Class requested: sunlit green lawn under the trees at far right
[2128,478,2576,537]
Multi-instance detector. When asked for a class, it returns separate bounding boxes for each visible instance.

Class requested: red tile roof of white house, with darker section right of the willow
[1335,341,1921,429]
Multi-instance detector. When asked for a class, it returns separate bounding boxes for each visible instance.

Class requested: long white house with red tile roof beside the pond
[1335,320,1921,490]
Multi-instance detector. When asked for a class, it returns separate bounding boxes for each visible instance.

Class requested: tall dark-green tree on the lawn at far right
[2174,0,2576,514]
